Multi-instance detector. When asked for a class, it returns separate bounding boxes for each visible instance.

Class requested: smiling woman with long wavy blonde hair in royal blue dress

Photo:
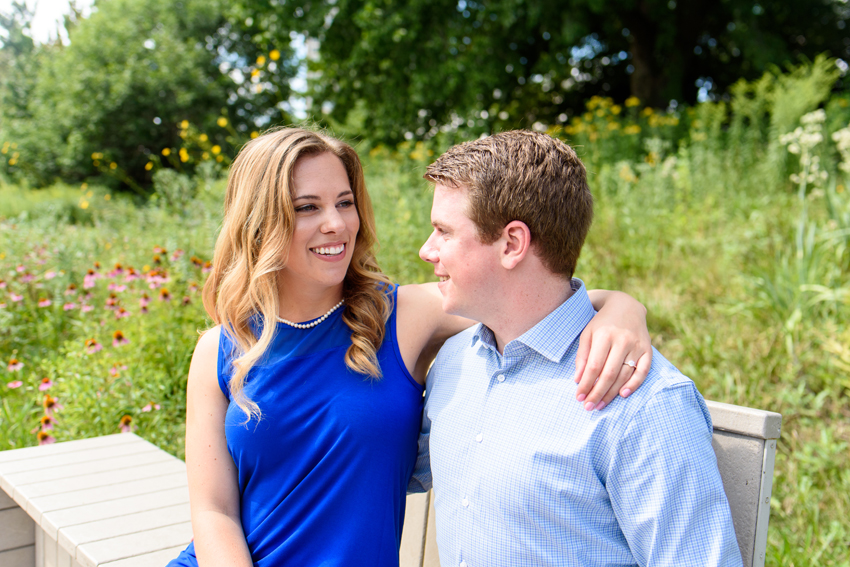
[167,129,651,567]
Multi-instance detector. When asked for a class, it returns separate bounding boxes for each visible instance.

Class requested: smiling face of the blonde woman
[280,153,360,291]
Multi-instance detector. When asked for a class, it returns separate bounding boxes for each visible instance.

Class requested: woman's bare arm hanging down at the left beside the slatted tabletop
[186,327,253,567]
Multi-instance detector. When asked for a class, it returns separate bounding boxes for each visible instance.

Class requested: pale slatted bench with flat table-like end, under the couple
[0,402,781,567]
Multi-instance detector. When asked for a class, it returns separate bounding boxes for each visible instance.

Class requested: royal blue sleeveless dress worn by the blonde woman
[168,287,423,567]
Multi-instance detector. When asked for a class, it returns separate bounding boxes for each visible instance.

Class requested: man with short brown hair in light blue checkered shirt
[411,131,741,567]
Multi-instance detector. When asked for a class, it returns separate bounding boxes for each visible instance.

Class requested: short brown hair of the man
[425,130,593,278]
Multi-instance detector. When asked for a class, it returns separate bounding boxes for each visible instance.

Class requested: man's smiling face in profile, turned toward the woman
[419,184,499,322]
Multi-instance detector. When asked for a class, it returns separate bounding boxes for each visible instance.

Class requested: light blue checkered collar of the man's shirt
[470,278,596,363]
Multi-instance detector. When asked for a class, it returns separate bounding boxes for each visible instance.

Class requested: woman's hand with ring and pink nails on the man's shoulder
[575,290,652,410]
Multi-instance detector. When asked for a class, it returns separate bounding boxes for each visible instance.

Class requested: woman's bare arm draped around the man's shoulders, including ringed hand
[397,283,652,409]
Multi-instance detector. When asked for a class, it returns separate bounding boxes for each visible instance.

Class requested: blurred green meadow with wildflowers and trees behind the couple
[0,0,850,566]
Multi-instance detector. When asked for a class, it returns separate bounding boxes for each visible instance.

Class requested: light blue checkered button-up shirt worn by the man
[411,279,741,567]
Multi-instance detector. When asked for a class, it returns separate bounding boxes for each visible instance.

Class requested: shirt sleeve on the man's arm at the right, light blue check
[607,382,742,567]
